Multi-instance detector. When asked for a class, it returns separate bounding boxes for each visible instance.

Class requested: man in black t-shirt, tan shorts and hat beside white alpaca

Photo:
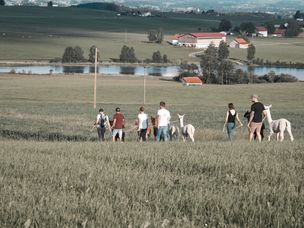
[247,94,266,142]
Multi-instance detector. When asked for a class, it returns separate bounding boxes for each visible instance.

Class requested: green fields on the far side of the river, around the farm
[0,7,304,64]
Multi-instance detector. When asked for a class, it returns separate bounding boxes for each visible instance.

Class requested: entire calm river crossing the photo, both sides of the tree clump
[0,65,304,80]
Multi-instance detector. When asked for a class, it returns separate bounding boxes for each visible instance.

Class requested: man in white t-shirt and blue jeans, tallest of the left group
[157,101,171,142]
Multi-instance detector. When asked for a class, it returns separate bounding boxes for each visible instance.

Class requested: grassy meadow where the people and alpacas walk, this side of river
[0,75,304,228]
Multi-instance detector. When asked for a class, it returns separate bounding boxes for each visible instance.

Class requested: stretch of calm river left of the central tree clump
[0,65,179,77]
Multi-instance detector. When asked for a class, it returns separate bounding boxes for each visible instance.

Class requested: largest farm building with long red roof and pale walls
[178,32,226,48]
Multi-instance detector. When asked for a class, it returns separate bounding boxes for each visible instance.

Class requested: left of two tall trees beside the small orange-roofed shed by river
[200,43,219,83]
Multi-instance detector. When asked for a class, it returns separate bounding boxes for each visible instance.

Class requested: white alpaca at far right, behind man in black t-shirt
[264,105,294,142]
